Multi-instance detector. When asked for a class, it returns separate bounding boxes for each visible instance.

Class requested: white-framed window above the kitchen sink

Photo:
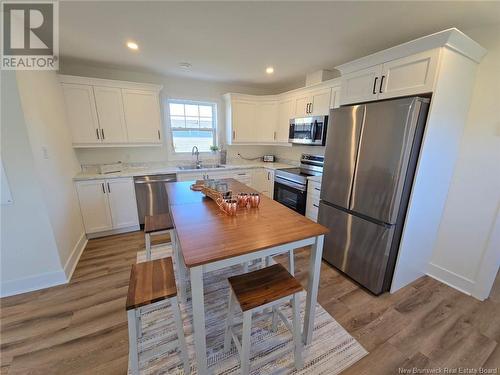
[168,100,217,152]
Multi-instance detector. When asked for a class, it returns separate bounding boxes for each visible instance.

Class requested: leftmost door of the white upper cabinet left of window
[62,84,101,144]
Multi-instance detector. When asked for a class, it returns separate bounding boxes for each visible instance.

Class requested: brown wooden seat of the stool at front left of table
[126,257,177,310]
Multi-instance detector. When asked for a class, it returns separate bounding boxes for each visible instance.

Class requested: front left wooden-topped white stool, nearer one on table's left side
[126,257,189,374]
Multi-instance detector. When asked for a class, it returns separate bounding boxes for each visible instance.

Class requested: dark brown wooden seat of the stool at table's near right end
[228,263,304,312]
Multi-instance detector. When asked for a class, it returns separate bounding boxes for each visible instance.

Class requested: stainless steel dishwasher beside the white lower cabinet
[134,174,177,226]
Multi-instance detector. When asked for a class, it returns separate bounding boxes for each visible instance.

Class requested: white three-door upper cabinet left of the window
[59,75,162,147]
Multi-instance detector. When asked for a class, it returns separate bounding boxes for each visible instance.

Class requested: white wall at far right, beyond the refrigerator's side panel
[429,25,500,299]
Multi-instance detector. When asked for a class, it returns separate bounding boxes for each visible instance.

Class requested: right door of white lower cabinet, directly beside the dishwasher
[106,178,139,229]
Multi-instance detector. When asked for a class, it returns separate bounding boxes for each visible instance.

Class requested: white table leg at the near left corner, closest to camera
[191,266,208,375]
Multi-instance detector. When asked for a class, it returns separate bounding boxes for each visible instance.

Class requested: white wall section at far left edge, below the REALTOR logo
[0,71,66,296]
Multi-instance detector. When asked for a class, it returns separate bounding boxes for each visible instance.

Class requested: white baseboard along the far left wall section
[0,270,66,297]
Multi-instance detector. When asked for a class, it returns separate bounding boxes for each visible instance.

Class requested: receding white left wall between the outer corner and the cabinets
[17,71,86,276]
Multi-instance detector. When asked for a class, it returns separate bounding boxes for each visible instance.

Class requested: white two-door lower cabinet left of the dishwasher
[76,178,139,234]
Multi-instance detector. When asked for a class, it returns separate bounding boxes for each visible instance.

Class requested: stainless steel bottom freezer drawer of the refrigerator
[318,202,394,294]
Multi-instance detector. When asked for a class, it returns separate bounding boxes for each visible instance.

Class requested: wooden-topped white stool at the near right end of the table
[224,264,303,374]
